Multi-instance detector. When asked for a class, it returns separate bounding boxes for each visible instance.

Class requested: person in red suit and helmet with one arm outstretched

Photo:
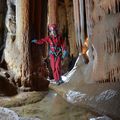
[32,24,68,85]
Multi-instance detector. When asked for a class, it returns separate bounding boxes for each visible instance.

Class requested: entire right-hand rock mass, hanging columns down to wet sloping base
[51,0,120,119]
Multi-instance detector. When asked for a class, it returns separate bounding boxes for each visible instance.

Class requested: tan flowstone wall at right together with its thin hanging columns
[73,0,120,82]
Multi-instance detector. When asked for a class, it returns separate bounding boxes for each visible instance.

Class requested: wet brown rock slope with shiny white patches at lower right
[50,77,120,120]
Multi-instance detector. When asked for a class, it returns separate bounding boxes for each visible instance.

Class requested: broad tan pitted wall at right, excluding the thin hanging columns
[86,0,120,82]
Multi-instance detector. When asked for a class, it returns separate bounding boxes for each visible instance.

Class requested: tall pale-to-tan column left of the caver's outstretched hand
[16,0,31,86]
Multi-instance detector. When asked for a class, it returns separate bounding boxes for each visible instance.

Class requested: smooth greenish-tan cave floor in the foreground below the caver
[0,90,97,120]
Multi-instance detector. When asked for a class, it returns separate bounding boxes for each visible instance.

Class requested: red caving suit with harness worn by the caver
[36,35,65,81]
